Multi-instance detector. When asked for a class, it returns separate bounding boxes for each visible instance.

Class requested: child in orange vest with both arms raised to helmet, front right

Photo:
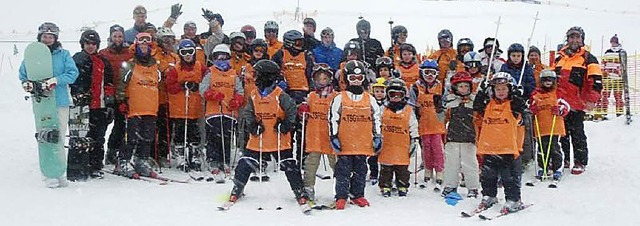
[473,72,526,212]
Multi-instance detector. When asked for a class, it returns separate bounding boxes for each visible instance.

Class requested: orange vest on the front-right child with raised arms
[477,100,520,157]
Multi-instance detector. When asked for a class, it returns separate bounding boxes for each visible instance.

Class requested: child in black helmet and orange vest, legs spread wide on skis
[229,60,307,205]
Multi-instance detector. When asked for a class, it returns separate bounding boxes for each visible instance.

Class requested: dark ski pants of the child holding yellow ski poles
[538,135,562,172]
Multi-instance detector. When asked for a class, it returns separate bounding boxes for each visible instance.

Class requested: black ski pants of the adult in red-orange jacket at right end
[560,110,589,166]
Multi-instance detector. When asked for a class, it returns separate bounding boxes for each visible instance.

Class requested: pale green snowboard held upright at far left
[24,42,67,178]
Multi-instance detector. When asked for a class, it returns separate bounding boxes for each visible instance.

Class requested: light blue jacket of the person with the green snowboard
[19,44,79,107]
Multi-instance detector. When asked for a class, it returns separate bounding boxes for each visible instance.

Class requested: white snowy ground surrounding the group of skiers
[0,0,640,226]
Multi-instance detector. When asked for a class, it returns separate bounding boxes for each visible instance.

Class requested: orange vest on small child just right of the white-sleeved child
[378,104,413,165]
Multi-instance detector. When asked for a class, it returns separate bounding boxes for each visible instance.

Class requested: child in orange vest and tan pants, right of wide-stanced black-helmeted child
[298,63,337,200]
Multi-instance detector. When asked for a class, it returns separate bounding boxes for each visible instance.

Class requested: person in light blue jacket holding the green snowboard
[19,22,79,188]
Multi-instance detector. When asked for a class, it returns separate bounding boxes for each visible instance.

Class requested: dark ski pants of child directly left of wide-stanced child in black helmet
[206,115,236,170]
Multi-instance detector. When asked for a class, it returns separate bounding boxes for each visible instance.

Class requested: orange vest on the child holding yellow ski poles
[531,90,565,137]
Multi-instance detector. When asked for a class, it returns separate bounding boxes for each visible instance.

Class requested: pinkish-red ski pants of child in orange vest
[420,134,444,175]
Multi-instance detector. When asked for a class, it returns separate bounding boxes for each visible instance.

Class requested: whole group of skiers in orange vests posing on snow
[20,4,617,214]
